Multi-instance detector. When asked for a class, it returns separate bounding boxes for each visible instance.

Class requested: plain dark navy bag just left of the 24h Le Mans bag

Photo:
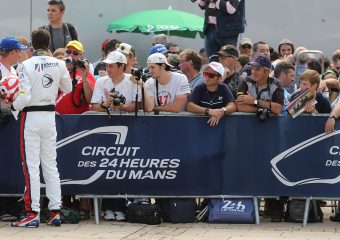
[161,198,196,223]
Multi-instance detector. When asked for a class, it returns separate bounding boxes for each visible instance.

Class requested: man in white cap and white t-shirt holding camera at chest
[91,51,141,112]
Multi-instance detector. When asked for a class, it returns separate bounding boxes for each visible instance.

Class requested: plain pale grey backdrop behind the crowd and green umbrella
[0,0,340,65]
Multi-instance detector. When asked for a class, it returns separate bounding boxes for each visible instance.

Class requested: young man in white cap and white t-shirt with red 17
[145,53,190,113]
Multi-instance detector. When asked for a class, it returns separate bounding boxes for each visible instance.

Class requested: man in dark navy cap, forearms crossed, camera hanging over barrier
[236,56,284,117]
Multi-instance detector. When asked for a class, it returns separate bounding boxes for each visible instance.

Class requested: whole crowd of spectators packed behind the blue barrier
[0,0,340,228]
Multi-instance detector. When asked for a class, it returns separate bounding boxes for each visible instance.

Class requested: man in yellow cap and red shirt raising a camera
[56,41,96,114]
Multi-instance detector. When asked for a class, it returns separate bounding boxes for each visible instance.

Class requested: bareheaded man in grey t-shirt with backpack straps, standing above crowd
[41,0,78,53]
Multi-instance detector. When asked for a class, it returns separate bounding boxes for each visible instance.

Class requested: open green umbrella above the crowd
[107,9,203,38]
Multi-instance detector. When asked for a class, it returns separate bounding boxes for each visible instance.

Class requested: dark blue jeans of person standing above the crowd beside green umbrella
[204,24,239,58]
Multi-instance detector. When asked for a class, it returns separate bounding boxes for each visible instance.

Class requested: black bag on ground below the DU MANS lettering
[125,203,162,225]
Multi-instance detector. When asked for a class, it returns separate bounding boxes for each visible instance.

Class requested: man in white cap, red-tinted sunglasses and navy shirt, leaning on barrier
[187,62,236,126]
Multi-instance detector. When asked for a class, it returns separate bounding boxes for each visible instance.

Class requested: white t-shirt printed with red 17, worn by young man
[145,72,190,106]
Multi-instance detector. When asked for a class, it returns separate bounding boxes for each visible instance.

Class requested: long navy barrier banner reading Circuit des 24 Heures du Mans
[0,114,340,225]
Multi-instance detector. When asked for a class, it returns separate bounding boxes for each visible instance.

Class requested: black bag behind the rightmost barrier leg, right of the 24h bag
[287,199,323,223]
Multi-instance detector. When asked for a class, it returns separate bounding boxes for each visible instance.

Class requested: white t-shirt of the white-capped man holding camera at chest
[91,74,142,105]
